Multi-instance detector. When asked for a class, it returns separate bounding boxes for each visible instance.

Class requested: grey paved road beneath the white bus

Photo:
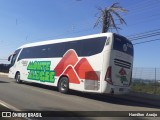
[0,75,160,120]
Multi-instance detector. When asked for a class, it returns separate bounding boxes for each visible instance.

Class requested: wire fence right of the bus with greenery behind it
[131,68,160,95]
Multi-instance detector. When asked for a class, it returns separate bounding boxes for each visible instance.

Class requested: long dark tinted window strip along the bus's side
[18,37,106,60]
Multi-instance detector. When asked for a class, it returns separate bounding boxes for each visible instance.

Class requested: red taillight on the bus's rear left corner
[105,66,113,84]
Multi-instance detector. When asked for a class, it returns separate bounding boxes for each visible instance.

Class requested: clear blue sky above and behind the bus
[0,0,160,68]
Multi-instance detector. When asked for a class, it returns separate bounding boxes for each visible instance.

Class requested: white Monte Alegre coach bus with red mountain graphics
[9,33,133,94]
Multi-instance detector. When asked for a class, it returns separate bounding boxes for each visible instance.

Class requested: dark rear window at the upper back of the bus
[113,34,133,56]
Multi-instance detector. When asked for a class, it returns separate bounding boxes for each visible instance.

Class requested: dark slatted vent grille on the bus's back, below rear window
[114,59,131,69]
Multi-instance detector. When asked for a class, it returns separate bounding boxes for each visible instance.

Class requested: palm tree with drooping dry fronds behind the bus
[94,3,128,33]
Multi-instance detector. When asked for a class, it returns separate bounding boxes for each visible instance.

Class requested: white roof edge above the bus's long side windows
[18,32,113,49]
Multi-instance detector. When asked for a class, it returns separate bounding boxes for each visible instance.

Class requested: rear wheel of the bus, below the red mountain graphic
[58,77,69,94]
